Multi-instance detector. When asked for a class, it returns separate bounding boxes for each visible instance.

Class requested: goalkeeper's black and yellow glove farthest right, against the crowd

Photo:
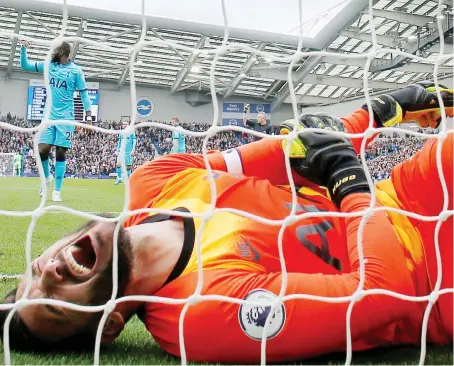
[362,81,454,128]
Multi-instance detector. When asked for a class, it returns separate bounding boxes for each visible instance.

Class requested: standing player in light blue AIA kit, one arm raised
[20,41,91,202]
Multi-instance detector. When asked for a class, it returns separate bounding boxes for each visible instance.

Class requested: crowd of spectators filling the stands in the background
[0,114,432,180]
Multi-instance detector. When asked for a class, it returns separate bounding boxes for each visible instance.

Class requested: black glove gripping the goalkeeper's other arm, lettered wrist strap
[280,114,370,207]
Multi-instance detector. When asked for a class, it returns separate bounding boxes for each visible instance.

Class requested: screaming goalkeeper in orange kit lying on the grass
[1,84,453,363]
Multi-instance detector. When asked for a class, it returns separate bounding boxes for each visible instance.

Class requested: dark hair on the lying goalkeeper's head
[0,287,97,352]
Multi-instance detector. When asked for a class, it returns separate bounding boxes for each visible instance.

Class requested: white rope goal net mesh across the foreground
[0,0,454,365]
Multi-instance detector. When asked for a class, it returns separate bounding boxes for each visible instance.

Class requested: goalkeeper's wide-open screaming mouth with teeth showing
[63,234,98,279]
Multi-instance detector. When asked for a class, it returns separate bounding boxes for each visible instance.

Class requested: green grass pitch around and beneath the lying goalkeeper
[0,178,453,365]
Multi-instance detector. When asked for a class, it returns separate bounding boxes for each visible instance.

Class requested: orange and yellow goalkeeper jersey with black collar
[126,109,452,363]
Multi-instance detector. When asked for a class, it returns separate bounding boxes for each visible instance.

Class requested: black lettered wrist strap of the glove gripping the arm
[326,165,370,207]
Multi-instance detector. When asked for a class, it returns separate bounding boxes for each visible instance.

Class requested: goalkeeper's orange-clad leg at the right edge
[391,130,454,339]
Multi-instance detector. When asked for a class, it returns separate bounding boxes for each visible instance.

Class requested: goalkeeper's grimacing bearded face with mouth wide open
[12,221,131,341]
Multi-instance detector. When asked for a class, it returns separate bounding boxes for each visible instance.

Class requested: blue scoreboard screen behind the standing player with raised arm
[27,80,99,121]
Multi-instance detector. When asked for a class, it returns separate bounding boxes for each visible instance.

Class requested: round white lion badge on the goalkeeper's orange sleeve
[238,289,285,341]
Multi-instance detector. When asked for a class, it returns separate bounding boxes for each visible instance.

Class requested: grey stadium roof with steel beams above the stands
[0,0,453,108]
